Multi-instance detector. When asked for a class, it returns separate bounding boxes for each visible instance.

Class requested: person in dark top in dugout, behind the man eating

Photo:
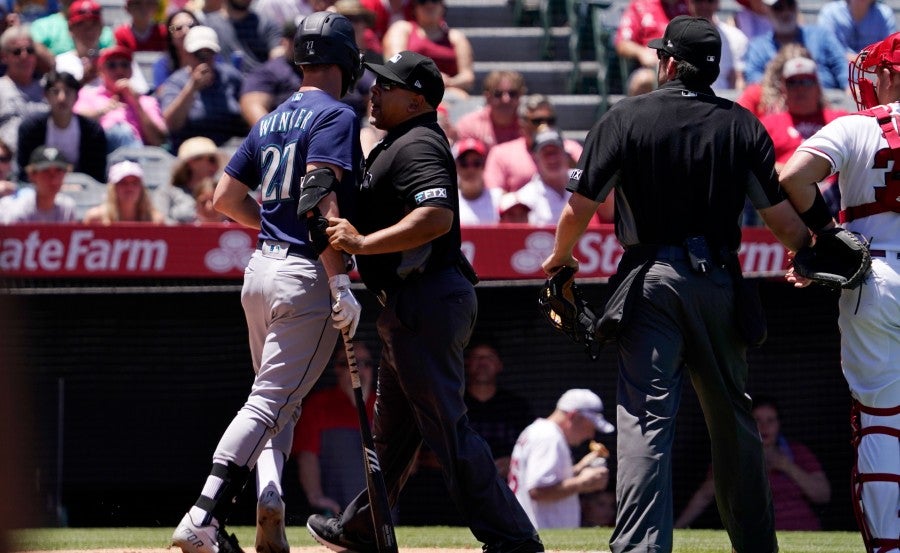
[465,341,534,480]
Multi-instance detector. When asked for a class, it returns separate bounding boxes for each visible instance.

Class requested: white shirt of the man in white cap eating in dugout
[509,419,581,530]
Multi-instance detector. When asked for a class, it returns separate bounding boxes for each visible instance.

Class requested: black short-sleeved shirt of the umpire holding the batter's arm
[351,112,461,292]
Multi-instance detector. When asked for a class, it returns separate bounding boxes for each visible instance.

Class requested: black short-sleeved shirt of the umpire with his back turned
[567,79,785,251]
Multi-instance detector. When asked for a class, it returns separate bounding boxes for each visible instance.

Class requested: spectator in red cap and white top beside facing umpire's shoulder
[453,138,503,225]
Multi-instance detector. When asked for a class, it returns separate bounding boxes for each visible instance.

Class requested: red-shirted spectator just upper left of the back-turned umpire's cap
[614,0,689,71]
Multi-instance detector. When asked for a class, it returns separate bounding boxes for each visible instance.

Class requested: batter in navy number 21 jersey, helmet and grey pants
[172,12,362,553]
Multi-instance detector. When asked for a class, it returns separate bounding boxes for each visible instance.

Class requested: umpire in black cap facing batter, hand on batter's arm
[307,51,544,553]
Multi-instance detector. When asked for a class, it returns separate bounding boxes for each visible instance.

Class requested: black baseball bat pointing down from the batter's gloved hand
[341,328,398,553]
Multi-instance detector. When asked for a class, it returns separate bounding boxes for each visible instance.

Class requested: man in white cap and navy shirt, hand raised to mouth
[156,25,248,149]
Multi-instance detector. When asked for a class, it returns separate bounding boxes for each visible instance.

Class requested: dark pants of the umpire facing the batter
[342,267,538,550]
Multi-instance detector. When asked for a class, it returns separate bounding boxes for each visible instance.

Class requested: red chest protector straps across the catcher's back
[838,106,900,224]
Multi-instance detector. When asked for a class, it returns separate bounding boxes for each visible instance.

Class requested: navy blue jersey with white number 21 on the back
[225,90,363,259]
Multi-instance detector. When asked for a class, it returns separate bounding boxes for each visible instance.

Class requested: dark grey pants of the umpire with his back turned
[610,254,778,553]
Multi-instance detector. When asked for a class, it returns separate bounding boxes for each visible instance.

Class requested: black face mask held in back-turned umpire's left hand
[538,267,597,356]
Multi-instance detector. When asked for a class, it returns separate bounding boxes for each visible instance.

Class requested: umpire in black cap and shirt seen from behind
[543,16,808,553]
